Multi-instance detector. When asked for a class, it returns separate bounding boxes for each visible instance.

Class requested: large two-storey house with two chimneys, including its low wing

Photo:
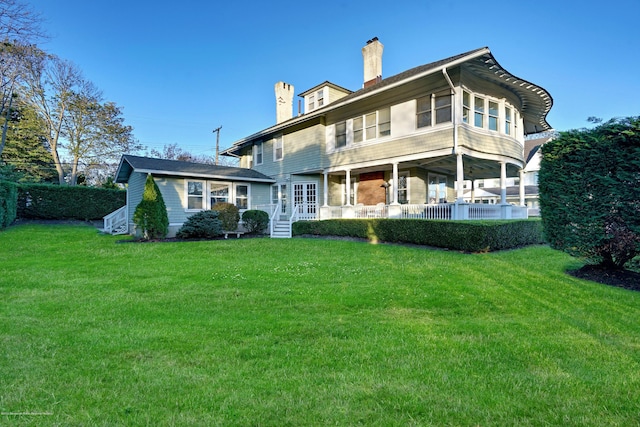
[104,38,553,235]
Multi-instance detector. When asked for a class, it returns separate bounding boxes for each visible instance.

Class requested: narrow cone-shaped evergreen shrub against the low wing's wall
[133,174,169,239]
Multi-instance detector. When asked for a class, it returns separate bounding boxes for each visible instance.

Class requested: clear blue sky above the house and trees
[24,0,640,156]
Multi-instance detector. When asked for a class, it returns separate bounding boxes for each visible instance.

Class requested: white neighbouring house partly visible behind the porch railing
[464,132,554,216]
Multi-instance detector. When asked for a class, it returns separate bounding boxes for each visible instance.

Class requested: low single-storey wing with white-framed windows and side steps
[104,155,275,236]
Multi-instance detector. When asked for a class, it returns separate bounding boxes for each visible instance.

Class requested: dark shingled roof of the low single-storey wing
[115,154,275,183]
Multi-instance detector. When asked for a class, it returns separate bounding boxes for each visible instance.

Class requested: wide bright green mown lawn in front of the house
[0,225,640,426]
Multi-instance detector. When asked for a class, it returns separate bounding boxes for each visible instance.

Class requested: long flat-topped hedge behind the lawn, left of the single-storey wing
[18,184,127,221]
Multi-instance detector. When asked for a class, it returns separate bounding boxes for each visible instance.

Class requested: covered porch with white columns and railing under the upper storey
[312,148,528,220]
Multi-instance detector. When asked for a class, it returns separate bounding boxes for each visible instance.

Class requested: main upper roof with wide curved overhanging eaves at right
[222,47,553,154]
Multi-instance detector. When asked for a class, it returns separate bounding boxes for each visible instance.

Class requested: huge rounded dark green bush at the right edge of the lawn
[539,117,640,269]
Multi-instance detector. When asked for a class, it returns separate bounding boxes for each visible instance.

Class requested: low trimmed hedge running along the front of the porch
[292,219,544,252]
